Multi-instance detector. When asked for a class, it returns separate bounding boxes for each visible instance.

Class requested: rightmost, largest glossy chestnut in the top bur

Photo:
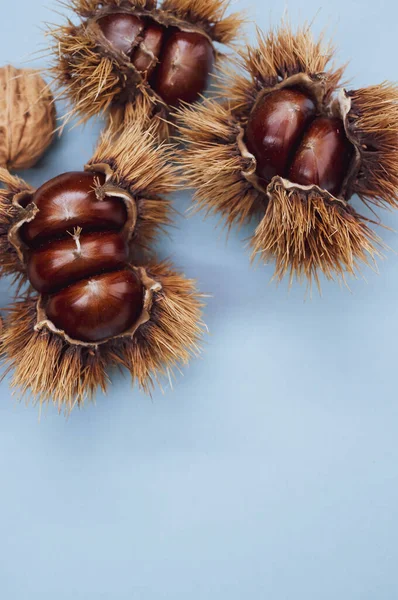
[154,31,215,106]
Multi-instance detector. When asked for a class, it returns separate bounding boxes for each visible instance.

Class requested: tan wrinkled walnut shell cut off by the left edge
[0,65,56,170]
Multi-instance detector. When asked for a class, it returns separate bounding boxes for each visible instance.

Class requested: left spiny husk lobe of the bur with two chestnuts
[178,99,264,227]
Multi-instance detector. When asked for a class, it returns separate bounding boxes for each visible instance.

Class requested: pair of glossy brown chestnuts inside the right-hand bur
[245,88,354,196]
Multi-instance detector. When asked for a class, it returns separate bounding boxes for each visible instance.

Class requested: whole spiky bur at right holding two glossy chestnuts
[179,23,398,285]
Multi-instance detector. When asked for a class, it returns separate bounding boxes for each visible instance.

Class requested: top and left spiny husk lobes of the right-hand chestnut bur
[177,21,344,227]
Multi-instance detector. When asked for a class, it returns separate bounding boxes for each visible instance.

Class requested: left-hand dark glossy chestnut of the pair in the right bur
[245,88,316,183]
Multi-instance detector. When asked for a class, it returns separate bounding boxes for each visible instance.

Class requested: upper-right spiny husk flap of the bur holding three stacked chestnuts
[89,121,180,249]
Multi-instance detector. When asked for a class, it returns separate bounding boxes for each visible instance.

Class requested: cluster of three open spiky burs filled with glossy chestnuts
[0,0,398,409]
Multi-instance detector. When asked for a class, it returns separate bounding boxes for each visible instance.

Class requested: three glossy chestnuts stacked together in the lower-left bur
[20,172,144,343]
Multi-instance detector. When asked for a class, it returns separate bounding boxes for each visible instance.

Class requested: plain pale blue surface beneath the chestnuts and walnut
[0,0,398,600]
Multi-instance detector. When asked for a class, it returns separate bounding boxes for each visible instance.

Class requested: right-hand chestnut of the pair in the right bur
[288,117,353,196]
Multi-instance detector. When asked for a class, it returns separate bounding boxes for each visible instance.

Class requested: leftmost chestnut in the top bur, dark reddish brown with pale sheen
[97,13,145,56]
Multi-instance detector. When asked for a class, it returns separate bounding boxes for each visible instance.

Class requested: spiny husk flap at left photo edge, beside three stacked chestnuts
[0,168,33,285]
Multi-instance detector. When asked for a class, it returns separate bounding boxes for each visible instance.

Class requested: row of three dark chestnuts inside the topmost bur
[97,13,215,106]
